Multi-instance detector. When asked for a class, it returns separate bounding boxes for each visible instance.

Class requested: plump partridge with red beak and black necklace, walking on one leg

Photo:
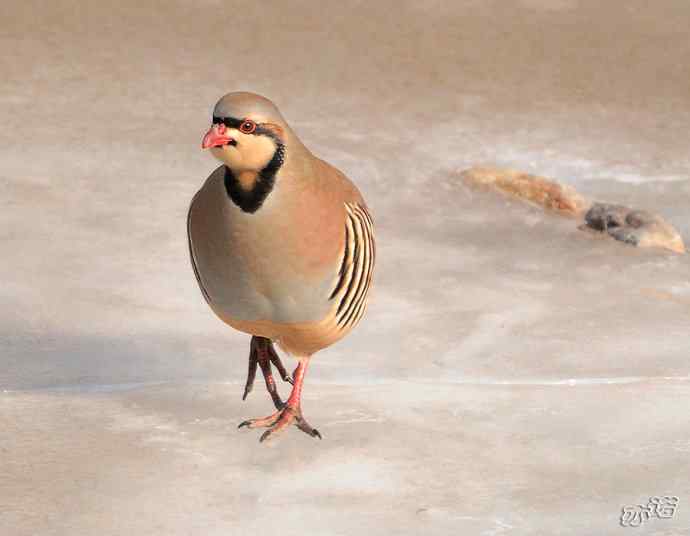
[187,92,376,442]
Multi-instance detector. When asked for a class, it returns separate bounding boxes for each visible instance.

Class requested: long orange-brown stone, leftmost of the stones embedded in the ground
[460,167,590,216]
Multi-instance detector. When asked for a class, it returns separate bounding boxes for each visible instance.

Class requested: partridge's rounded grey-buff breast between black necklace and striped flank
[188,169,345,323]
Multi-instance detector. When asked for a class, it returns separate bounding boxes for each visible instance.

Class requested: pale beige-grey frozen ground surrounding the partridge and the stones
[0,0,690,536]
